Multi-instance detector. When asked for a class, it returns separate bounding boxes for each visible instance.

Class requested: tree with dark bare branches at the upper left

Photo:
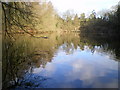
[0,2,34,37]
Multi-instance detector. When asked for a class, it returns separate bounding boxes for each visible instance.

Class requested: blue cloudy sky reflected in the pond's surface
[29,46,118,88]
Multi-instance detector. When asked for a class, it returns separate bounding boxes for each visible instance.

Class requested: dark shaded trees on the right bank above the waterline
[80,4,120,37]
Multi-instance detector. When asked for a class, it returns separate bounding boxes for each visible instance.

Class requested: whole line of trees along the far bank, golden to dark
[0,2,120,36]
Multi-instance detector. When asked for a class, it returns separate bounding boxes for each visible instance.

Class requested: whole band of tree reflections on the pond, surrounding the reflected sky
[3,33,120,87]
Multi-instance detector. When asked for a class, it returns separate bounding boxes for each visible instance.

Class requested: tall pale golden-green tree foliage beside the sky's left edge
[32,2,56,31]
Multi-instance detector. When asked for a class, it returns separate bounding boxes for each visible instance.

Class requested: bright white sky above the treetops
[47,0,120,14]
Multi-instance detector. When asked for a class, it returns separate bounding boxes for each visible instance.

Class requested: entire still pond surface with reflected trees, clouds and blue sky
[3,33,120,88]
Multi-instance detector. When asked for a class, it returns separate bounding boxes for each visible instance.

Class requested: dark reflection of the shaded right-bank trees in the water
[80,33,120,60]
